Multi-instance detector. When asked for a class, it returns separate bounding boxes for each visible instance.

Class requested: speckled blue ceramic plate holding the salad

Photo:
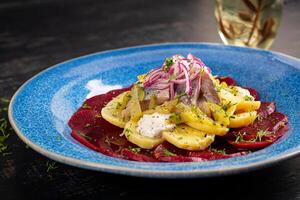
[9,43,300,178]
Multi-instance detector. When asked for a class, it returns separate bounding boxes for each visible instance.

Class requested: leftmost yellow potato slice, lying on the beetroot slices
[101,91,130,128]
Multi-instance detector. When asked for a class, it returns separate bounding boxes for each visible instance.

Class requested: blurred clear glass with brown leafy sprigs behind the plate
[215,0,283,49]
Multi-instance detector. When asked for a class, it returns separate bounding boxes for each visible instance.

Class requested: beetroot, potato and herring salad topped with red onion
[69,54,288,162]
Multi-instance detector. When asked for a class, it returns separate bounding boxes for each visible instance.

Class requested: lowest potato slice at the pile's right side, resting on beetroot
[228,111,257,128]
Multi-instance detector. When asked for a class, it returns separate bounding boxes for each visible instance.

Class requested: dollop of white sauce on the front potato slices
[137,113,175,138]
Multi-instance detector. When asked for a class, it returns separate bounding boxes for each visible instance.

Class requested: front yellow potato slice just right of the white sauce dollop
[162,125,215,151]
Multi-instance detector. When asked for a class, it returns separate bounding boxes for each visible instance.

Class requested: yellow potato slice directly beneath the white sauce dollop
[123,121,164,149]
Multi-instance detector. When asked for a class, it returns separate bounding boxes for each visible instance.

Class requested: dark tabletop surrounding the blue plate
[0,0,300,200]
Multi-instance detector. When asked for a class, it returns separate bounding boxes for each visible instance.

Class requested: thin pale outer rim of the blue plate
[8,42,300,178]
